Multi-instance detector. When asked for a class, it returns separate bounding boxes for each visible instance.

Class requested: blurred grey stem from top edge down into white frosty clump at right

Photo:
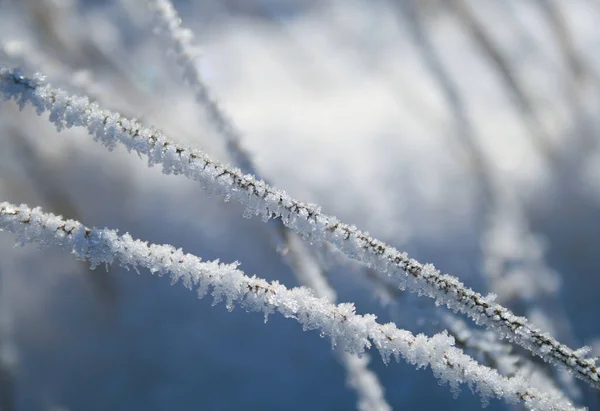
[392,0,576,400]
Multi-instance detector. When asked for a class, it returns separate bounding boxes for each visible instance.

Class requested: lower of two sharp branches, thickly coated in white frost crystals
[0,203,574,410]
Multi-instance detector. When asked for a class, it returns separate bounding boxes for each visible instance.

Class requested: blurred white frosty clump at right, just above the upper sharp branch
[481,191,581,398]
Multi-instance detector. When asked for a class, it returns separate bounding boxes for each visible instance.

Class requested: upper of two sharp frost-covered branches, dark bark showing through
[0,69,600,388]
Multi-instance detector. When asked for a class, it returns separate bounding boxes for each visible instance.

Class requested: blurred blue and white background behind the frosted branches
[0,0,600,411]
